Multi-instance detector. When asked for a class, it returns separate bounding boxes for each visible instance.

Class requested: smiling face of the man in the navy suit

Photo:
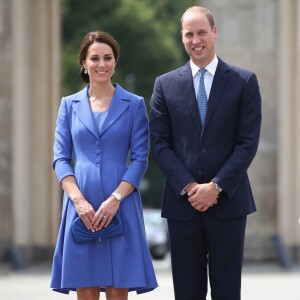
[181,11,218,68]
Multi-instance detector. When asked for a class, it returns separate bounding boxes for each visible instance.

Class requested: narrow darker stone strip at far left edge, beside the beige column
[0,0,13,259]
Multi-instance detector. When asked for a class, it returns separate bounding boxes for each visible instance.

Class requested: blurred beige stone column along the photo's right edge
[277,0,300,254]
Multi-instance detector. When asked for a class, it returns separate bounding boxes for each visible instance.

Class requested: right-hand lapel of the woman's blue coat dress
[100,84,129,136]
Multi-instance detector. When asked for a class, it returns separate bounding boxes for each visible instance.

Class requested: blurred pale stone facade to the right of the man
[198,0,300,260]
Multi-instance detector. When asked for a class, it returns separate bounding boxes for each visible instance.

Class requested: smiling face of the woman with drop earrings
[82,42,116,84]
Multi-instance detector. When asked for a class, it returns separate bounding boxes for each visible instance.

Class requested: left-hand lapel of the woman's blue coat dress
[73,86,99,138]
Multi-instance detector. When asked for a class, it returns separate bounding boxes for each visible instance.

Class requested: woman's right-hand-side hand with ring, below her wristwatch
[92,196,120,231]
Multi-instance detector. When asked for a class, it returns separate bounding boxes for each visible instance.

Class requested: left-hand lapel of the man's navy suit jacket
[179,62,202,134]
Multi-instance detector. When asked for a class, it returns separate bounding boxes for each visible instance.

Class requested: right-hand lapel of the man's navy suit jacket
[203,58,229,130]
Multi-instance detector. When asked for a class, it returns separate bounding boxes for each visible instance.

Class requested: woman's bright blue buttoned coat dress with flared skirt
[51,85,157,293]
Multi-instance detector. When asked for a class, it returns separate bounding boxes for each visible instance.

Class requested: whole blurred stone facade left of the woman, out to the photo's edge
[0,0,60,267]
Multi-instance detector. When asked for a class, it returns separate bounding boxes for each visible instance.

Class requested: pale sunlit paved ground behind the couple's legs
[0,255,300,300]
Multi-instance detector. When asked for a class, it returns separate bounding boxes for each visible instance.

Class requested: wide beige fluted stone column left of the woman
[11,0,60,261]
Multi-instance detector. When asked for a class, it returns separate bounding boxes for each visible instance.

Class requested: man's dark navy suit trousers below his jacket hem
[168,209,247,300]
